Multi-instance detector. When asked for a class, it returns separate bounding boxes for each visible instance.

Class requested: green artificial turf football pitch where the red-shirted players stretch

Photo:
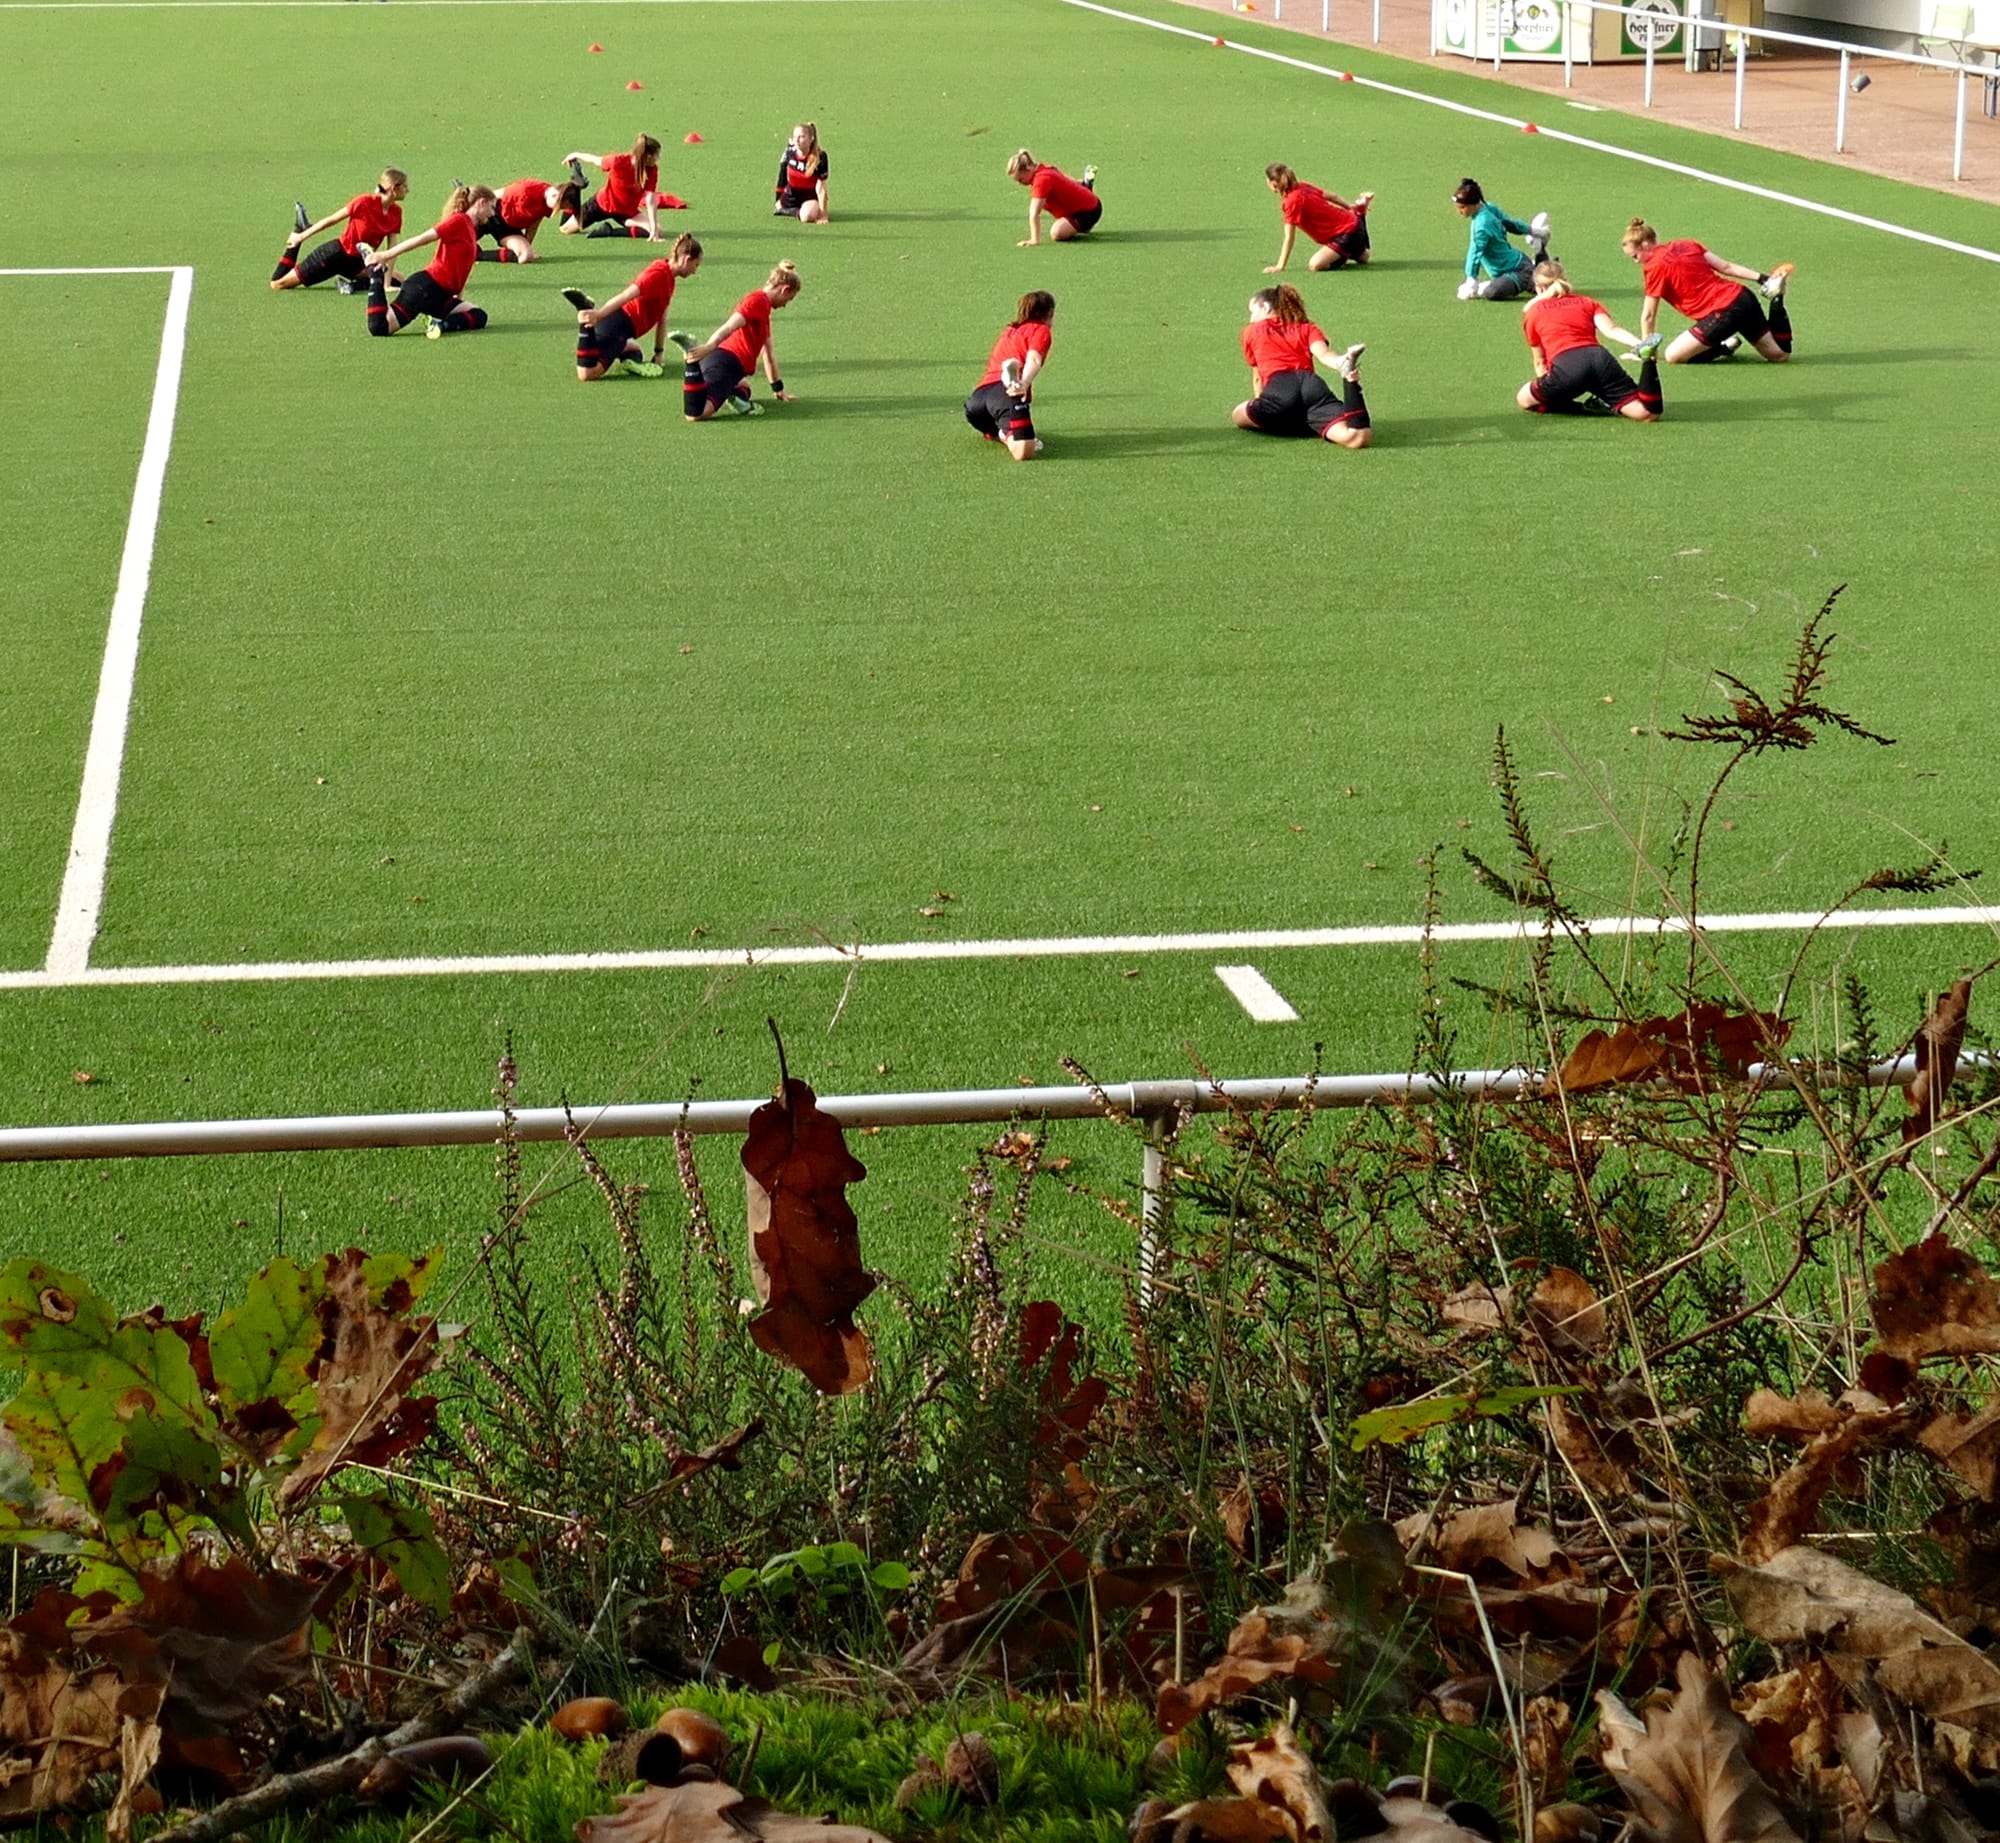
[0,0,2000,1297]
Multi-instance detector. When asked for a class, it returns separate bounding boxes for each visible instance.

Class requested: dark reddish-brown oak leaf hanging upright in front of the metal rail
[742,1077,876,1395]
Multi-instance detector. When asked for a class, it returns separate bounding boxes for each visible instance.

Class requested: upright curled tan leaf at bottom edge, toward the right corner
[1598,1651,1798,1843]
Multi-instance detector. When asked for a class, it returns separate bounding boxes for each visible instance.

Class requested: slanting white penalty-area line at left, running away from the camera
[48,268,194,977]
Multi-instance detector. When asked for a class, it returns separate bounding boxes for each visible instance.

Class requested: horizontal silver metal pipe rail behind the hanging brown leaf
[0,1055,1936,1163]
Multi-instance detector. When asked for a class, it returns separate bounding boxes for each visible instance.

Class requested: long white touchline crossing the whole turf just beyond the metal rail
[0,908,2000,991]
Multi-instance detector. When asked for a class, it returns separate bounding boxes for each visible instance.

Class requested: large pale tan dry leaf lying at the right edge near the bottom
[1708,1545,2000,1737]
